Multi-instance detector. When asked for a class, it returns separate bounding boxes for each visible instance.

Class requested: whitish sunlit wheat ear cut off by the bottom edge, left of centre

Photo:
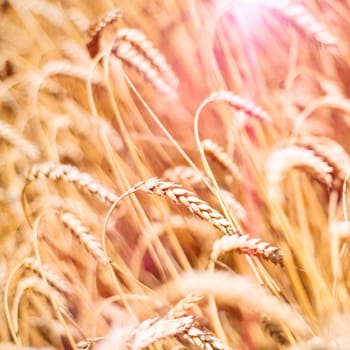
[131,316,194,350]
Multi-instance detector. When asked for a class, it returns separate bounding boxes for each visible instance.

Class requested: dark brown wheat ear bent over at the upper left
[86,9,122,57]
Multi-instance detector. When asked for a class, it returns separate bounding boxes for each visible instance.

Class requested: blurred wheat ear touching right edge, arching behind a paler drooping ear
[295,136,350,186]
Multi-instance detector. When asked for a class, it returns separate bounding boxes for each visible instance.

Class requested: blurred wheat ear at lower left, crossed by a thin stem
[23,258,72,295]
